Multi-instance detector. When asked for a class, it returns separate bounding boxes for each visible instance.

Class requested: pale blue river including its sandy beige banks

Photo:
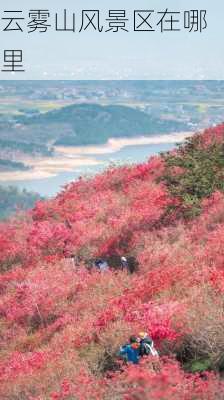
[0,133,192,197]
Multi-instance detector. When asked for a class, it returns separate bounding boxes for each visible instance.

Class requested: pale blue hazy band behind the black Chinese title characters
[0,0,224,79]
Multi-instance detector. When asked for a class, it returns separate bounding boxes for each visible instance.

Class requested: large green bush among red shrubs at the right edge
[162,137,224,218]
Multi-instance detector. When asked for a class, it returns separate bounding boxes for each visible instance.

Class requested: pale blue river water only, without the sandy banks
[4,143,175,197]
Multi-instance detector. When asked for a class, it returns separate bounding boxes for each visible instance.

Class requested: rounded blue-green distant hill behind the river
[17,104,189,146]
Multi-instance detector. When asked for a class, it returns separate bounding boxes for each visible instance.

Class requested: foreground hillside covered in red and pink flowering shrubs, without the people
[0,125,224,400]
